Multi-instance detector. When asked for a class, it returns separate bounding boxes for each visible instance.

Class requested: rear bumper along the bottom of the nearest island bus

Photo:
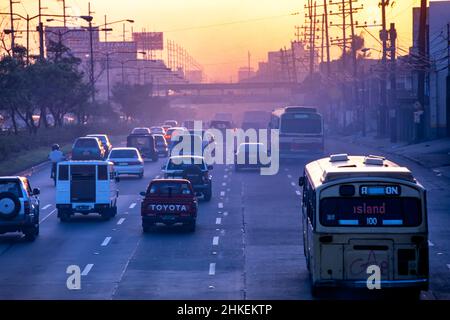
[315,278,429,291]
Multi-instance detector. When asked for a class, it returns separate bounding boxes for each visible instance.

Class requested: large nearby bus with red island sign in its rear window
[299,154,429,297]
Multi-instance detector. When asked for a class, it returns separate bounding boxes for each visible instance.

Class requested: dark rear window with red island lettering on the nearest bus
[320,197,422,227]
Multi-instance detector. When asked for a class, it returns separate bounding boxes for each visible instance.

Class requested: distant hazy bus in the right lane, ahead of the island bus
[269,106,324,158]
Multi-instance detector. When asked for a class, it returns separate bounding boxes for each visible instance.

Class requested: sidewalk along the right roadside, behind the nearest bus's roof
[342,131,450,178]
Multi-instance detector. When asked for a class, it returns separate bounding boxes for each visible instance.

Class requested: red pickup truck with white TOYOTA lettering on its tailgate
[141,179,198,232]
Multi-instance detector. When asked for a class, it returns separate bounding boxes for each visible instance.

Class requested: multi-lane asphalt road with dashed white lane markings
[0,140,450,299]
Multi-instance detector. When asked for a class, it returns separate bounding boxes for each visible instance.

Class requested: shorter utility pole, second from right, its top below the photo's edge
[389,23,398,143]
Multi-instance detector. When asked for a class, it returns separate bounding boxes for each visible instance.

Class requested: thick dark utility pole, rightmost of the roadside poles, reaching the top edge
[416,0,427,141]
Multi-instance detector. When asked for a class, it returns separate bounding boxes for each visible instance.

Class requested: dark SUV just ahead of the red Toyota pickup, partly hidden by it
[162,155,213,201]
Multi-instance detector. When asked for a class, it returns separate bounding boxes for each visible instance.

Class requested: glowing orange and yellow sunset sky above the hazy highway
[0,0,442,81]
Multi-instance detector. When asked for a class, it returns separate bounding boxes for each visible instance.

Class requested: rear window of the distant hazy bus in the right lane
[280,113,322,134]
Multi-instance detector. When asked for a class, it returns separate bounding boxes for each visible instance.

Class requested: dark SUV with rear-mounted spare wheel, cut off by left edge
[0,177,40,241]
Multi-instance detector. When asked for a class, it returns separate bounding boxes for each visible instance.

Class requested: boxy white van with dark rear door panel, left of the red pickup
[56,160,119,222]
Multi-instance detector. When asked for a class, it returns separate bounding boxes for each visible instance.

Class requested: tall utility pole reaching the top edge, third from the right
[378,0,389,137]
